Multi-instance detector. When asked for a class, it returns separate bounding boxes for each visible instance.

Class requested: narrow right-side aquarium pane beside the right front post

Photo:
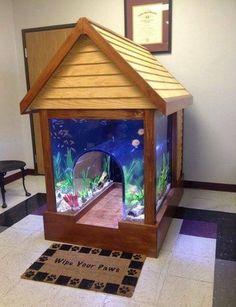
[155,111,171,211]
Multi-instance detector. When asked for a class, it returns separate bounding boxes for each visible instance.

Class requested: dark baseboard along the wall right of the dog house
[184,180,236,192]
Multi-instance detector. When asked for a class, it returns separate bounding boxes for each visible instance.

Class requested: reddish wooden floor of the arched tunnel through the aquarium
[78,187,122,228]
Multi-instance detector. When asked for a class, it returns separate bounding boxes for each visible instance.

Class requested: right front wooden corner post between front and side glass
[144,110,156,225]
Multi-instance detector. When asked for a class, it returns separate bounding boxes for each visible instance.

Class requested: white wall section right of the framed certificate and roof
[160,0,236,184]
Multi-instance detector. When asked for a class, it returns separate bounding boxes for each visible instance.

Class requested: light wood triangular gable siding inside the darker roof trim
[30,35,155,110]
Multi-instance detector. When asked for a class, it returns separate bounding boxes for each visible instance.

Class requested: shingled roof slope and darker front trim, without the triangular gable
[20,17,192,115]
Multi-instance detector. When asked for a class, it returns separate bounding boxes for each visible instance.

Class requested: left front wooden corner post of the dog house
[40,110,57,212]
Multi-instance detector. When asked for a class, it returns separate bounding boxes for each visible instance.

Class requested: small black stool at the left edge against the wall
[0,160,31,208]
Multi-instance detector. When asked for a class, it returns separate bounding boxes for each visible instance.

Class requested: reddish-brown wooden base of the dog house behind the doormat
[44,188,183,257]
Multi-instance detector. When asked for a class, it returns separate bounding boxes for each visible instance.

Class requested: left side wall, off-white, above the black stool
[0,0,30,160]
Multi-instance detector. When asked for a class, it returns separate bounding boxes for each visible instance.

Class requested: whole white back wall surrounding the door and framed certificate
[2,0,236,184]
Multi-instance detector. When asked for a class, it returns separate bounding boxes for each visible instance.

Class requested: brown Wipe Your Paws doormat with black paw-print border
[21,243,146,297]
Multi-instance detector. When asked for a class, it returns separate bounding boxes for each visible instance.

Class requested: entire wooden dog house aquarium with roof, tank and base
[21,18,192,257]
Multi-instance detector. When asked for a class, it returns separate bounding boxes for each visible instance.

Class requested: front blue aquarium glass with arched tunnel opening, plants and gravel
[50,119,144,221]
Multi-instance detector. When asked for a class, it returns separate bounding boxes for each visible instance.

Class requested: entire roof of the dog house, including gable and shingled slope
[20,17,192,115]
